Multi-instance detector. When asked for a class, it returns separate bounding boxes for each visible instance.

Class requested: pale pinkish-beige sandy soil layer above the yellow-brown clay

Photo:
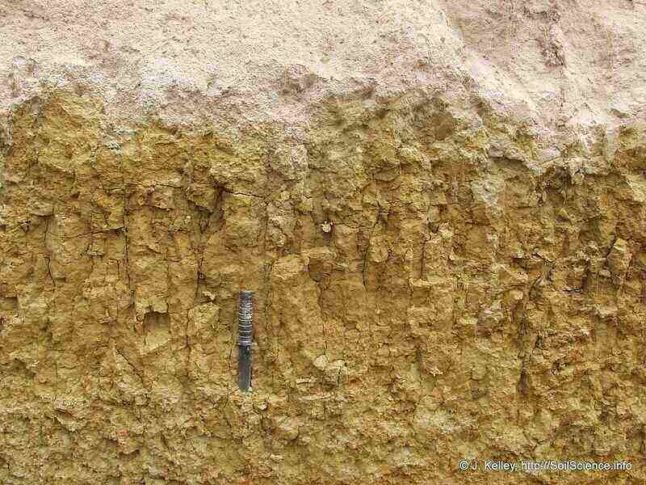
[0,0,646,128]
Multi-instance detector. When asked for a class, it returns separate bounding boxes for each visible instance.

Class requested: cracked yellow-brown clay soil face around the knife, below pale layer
[0,90,646,483]
